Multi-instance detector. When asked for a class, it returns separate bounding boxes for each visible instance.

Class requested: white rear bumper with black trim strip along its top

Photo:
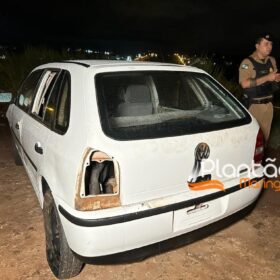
[57,178,263,258]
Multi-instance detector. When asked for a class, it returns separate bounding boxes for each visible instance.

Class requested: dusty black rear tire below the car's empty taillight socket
[43,190,83,279]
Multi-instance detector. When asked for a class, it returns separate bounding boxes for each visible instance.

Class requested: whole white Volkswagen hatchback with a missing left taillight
[7,60,263,278]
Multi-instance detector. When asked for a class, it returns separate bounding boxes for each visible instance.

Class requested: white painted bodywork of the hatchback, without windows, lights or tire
[7,61,262,257]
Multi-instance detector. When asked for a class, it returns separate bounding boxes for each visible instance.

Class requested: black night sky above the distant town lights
[0,0,280,56]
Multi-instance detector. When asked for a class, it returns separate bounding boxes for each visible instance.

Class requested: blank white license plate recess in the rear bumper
[173,198,225,232]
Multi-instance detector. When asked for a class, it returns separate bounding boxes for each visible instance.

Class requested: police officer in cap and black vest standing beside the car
[239,33,280,143]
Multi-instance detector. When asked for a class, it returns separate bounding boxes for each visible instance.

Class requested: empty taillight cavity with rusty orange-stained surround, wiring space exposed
[75,149,120,211]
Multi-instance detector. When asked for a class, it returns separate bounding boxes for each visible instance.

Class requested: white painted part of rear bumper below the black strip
[57,183,261,257]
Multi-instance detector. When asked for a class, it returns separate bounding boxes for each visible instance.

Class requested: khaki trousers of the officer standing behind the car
[249,102,273,144]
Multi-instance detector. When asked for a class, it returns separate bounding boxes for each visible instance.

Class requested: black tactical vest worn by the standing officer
[243,56,274,99]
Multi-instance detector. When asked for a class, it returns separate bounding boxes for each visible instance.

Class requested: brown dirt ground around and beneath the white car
[0,126,280,280]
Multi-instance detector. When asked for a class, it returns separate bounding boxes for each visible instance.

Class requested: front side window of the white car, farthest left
[16,69,44,112]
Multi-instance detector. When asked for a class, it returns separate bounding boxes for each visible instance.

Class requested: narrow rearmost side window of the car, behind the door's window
[54,71,71,133]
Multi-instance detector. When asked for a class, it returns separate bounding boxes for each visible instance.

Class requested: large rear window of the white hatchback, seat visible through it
[96,71,251,140]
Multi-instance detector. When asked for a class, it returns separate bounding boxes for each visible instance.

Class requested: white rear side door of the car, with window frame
[22,69,61,197]
